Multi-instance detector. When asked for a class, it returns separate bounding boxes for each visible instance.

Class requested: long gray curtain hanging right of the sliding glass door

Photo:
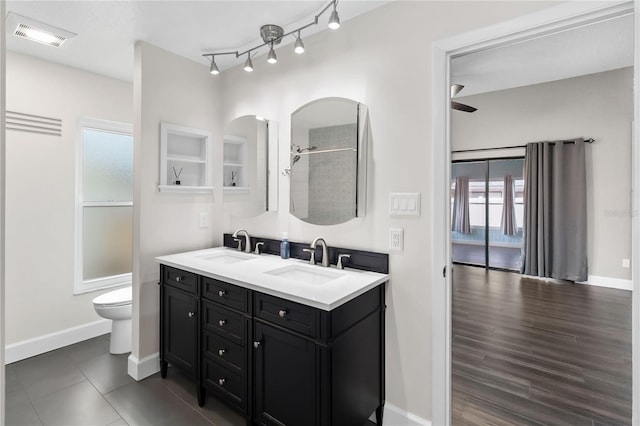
[521,139,587,281]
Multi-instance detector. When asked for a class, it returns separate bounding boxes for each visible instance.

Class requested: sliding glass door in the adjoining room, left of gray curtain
[451,158,524,271]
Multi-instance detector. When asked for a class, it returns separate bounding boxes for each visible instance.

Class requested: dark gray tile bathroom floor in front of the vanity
[6,334,245,426]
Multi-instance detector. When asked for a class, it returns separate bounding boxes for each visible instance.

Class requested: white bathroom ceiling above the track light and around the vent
[6,0,389,81]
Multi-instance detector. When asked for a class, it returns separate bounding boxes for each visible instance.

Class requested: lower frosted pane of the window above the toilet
[82,206,133,280]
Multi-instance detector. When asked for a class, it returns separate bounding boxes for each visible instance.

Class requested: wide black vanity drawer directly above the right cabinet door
[253,292,320,337]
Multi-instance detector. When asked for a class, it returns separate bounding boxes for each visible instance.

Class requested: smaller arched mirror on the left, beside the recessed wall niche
[223,115,278,217]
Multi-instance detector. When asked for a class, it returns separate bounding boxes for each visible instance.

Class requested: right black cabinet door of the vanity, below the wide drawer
[254,322,319,426]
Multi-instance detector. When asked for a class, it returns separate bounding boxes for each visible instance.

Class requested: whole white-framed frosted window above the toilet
[74,119,133,294]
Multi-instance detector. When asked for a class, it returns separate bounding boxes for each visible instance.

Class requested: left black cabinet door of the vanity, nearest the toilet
[162,286,198,379]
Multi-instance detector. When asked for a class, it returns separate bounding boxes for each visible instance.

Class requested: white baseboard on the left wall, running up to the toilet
[4,319,111,364]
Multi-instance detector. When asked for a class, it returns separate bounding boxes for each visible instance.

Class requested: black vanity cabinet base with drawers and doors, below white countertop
[160,265,385,426]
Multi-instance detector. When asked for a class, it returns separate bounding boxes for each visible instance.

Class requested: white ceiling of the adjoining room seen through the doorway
[451,15,634,97]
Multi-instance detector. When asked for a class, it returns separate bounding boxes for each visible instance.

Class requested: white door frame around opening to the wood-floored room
[430,1,640,425]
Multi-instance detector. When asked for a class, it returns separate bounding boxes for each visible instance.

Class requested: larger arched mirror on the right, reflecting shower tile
[285,98,369,225]
